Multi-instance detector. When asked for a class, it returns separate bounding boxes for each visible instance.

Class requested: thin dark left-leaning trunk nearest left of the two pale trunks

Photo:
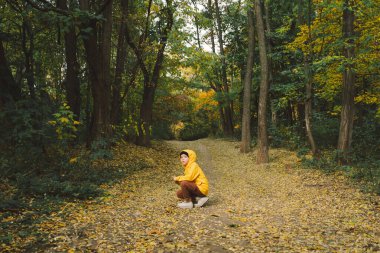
[215,0,234,135]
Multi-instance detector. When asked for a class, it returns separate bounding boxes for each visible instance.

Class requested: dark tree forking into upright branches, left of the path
[126,0,173,146]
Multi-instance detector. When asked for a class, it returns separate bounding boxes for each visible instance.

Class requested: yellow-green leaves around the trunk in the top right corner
[286,0,380,105]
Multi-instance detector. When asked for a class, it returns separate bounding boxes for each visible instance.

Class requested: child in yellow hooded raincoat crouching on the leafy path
[173,149,208,208]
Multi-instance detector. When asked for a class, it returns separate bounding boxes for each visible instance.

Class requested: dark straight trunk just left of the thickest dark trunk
[57,0,81,119]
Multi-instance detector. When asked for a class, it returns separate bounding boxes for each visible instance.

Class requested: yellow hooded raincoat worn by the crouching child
[175,149,208,195]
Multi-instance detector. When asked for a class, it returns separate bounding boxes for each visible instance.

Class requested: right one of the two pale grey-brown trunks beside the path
[255,0,269,164]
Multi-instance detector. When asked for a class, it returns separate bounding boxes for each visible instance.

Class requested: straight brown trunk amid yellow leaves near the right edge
[338,0,355,163]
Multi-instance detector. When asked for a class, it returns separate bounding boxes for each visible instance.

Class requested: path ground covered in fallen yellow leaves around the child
[3,139,380,252]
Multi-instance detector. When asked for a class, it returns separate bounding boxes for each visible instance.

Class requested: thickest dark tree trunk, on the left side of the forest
[79,0,113,140]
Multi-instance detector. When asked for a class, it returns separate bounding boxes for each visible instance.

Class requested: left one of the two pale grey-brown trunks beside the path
[240,7,255,153]
